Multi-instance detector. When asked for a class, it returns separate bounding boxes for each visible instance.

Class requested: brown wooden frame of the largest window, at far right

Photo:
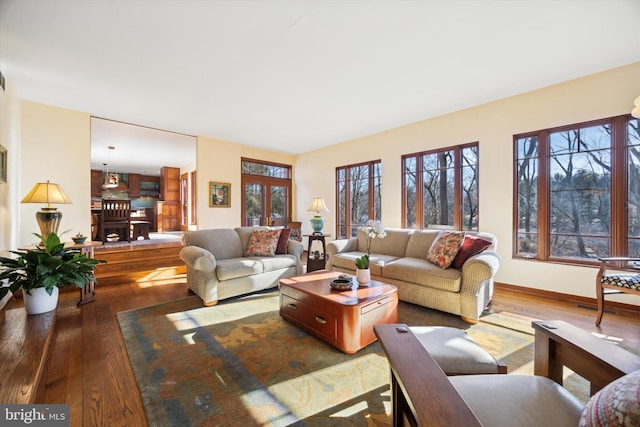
[512,114,633,265]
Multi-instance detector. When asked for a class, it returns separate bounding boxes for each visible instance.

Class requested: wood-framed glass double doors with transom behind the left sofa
[241,158,291,227]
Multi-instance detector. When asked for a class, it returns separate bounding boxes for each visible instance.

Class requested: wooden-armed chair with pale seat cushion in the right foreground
[373,320,640,427]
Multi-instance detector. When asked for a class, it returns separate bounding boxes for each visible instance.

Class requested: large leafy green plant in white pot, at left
[0,233,105,314]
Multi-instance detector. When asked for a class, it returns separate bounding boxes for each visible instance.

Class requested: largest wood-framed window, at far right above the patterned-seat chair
[514,116,640,263]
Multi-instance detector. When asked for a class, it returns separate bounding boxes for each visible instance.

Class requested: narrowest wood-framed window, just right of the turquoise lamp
[336,160,382,238]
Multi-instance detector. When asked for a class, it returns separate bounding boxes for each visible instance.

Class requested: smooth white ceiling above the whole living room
[0,0,640,167]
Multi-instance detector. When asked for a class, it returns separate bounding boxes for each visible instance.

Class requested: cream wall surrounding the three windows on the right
[295,63,640,303]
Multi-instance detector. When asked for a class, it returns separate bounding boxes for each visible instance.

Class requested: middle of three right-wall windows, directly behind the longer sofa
[402,142,478,230]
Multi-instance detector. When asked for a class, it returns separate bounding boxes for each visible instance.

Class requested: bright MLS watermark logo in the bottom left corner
[0,404,69,427]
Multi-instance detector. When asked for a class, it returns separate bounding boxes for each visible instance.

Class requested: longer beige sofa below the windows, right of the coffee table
[326,229,501,323]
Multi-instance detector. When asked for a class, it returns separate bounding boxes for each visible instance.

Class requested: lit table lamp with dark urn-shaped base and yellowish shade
[21,181,71,240]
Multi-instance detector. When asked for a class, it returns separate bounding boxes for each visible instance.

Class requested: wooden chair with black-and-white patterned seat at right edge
[596,257,640,326]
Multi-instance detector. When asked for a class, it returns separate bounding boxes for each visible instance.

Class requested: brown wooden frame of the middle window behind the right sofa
[400,141,480,231]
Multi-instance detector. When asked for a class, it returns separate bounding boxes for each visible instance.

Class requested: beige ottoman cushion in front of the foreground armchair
[408,326,507,375]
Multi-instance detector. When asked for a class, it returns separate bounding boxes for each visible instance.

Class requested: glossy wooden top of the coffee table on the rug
[280,270,397,305]
